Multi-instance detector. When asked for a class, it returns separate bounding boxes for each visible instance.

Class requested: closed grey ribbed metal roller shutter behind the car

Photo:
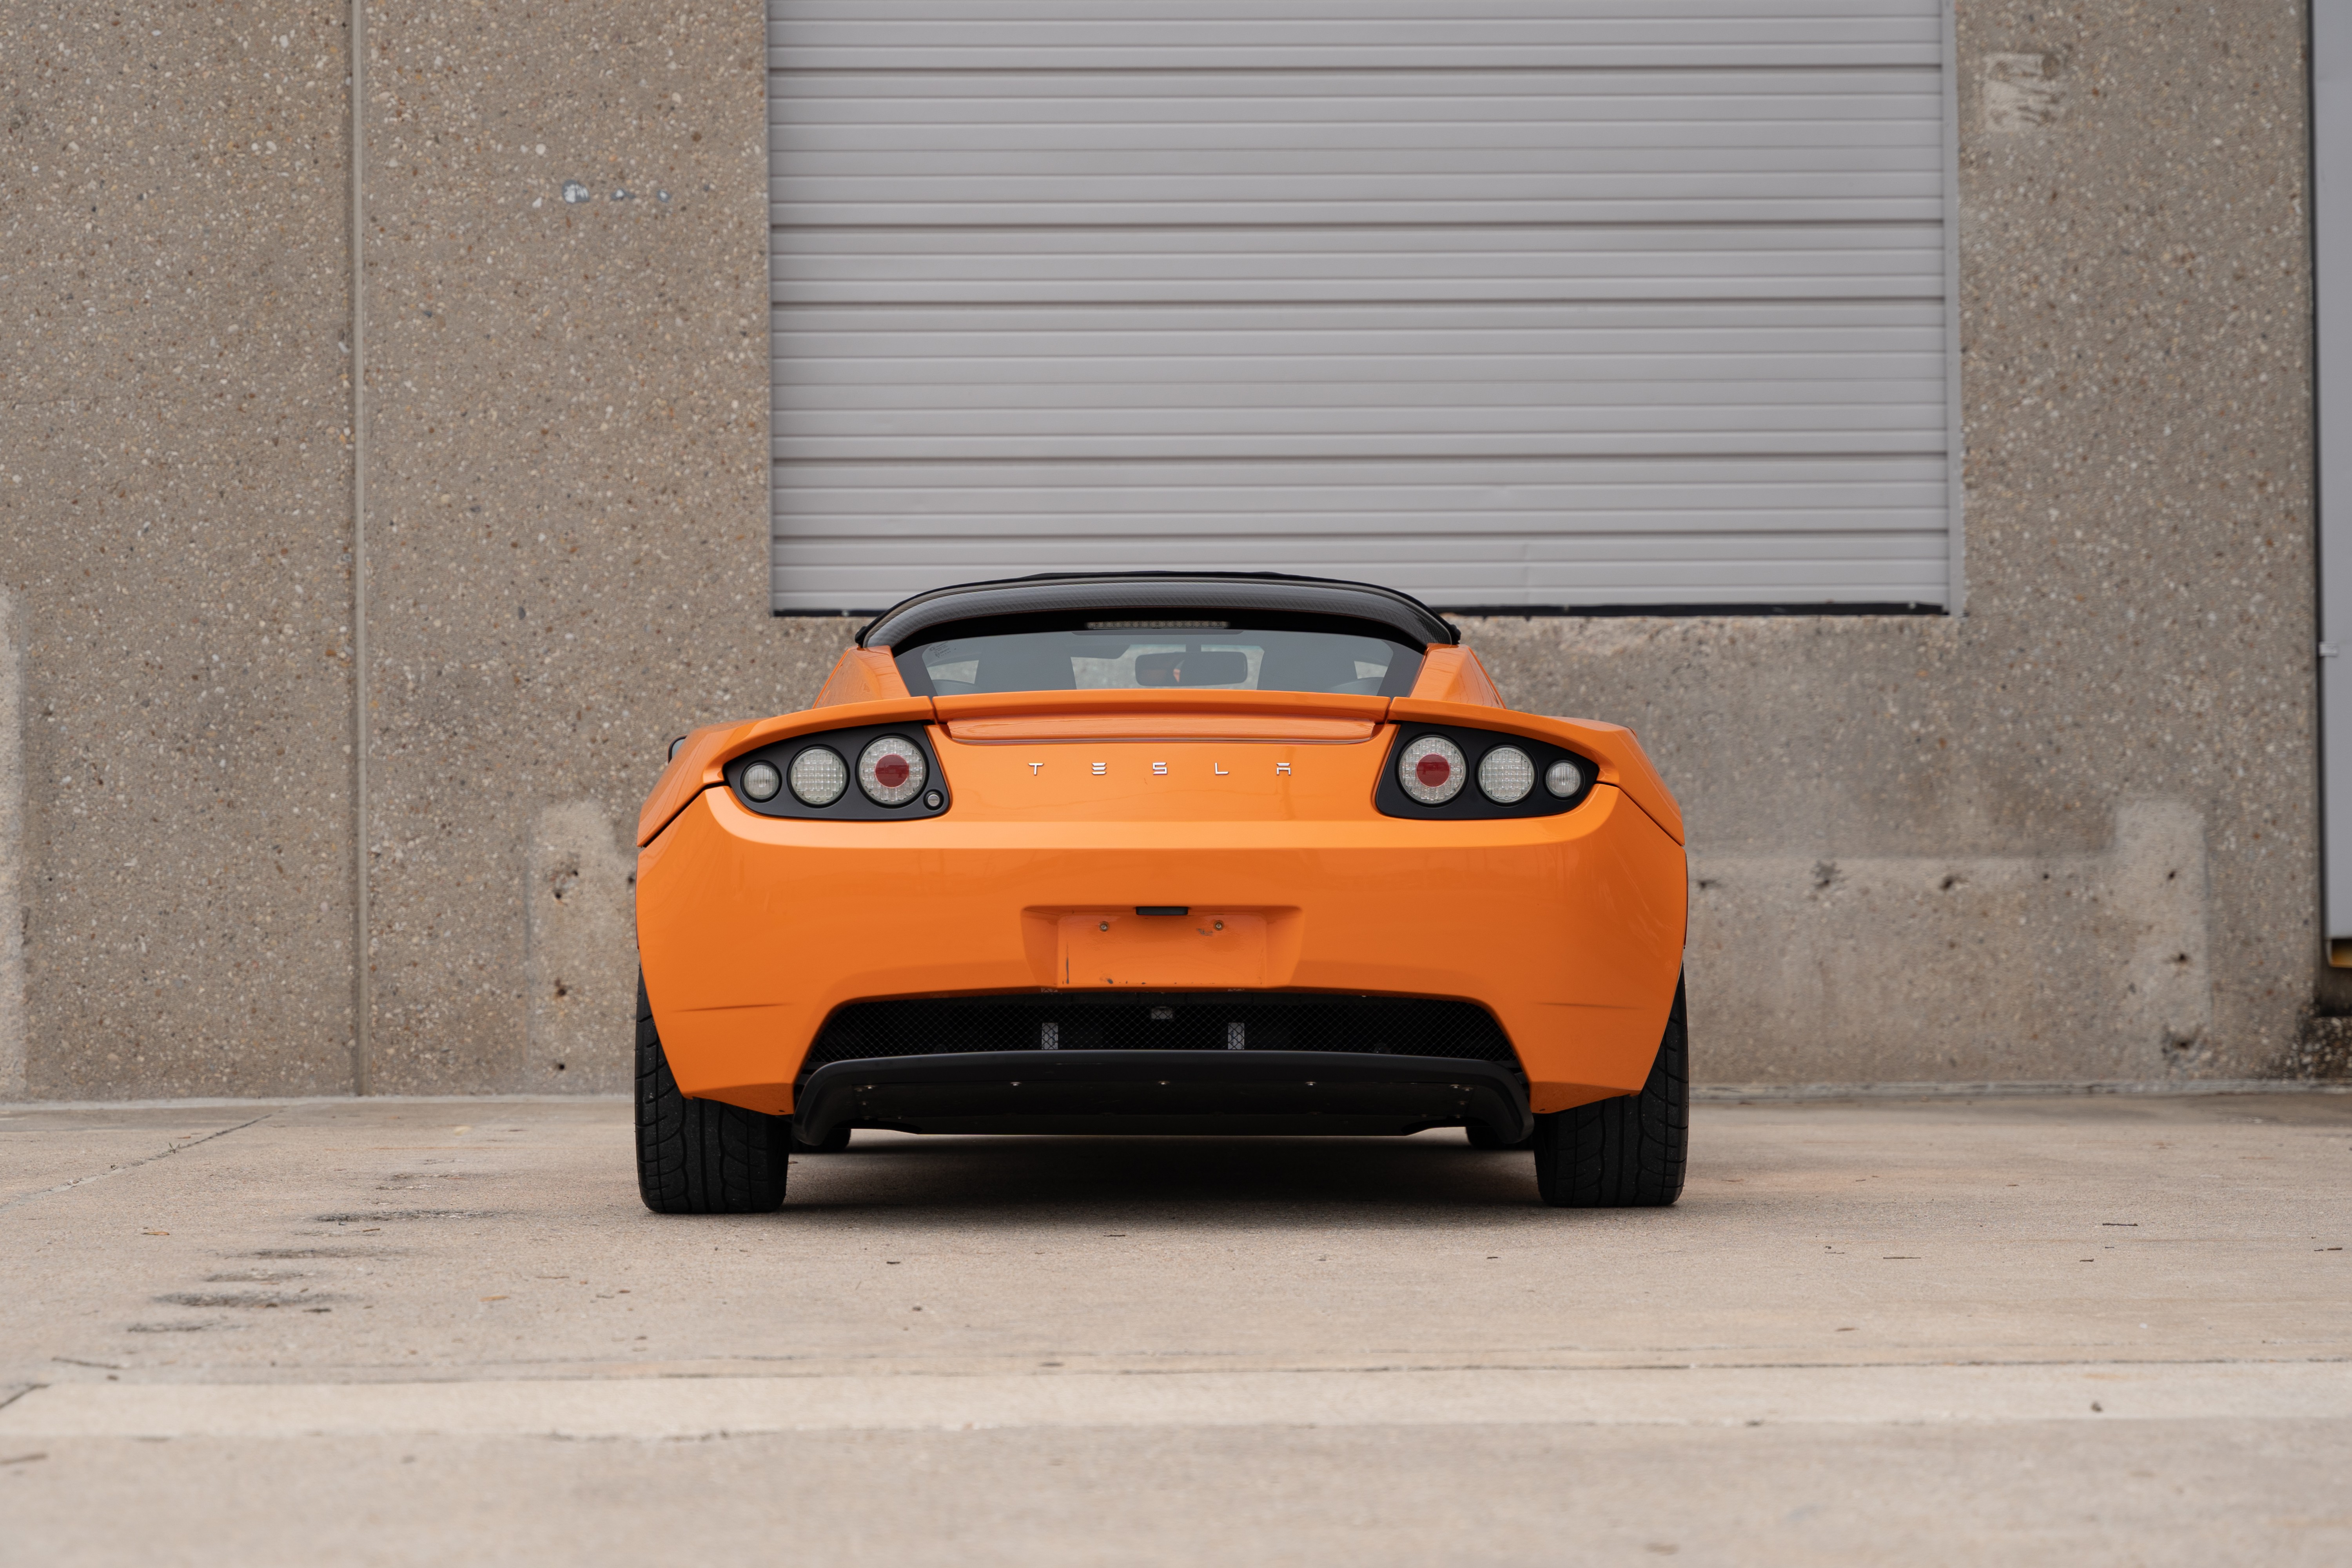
[769,0,1957,611]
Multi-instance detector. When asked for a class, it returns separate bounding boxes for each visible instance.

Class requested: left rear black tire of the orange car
[637,971,793,1213]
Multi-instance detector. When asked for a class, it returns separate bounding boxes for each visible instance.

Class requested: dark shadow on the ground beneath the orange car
[786,1133,1536,1218]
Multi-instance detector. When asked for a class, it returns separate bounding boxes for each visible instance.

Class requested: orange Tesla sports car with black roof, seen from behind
[637,573,1689,1213]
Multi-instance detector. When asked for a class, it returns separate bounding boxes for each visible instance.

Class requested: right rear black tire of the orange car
[1536,978,1691,1208]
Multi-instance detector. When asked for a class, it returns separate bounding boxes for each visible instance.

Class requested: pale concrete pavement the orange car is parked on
[0,1093,2352,1566]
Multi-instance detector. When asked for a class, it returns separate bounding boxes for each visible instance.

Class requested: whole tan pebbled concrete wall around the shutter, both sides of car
[0,0,2343,1096]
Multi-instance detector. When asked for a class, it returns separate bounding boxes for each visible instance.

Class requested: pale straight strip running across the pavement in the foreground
[0,1361,2352,1441]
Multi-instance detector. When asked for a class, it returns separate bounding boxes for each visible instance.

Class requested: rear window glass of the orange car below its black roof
[896,621,1421,696]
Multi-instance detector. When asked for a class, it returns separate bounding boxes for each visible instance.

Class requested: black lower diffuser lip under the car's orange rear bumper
[793,1051,1536,1143]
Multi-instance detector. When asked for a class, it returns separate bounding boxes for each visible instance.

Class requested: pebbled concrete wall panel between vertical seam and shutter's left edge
[367,0,844,1091]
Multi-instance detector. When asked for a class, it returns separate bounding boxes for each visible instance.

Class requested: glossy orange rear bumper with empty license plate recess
[637,771,1686,1112]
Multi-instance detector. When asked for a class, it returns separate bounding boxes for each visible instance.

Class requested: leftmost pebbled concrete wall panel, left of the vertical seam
[0,0,353,1098]
